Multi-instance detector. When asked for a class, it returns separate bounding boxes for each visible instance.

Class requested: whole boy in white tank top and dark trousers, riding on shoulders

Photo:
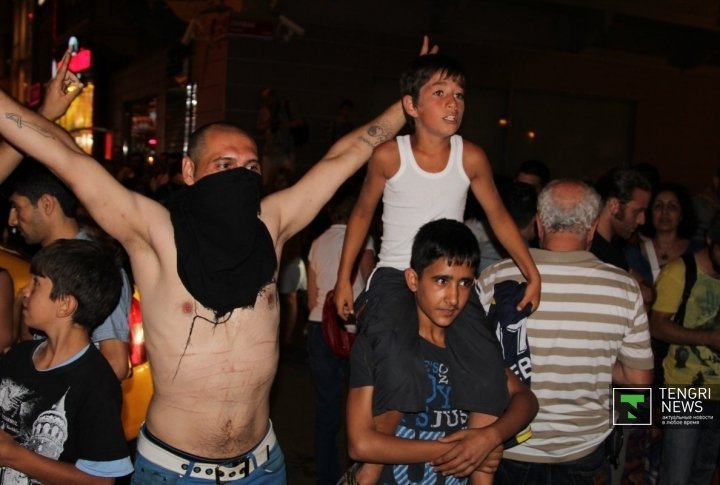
[335,46,540,468]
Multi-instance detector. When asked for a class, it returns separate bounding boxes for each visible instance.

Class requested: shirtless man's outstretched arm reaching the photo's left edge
[0,91,162,254]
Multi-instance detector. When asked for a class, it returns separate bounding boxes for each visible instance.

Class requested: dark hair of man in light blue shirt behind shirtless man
[11,158,78,218]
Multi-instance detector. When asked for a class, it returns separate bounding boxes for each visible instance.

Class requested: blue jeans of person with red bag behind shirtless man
[307,322,348,485]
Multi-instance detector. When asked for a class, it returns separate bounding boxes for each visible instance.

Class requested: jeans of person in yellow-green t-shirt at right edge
[659,403,720,485]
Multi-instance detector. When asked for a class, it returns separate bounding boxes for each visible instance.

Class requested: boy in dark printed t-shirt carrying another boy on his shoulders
[345,219,537,484]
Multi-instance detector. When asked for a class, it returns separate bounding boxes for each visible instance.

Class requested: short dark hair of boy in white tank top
[400,54,465,126]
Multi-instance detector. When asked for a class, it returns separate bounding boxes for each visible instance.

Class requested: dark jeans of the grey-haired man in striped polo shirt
[495,444,610,485]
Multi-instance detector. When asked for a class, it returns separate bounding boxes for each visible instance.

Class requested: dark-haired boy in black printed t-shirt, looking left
[0,240,133,484]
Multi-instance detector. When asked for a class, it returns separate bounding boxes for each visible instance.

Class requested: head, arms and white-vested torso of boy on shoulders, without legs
[335,53,540,317]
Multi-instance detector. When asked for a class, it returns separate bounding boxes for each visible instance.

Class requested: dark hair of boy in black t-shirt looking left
[30,239,122,333]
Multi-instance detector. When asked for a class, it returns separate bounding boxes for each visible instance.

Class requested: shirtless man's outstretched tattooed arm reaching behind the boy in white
[260,101,405,245]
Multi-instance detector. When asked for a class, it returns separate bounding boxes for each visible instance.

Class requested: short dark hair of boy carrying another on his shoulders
[410,219,480,276]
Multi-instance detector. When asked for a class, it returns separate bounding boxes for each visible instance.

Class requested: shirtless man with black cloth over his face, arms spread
[0,39,428,483]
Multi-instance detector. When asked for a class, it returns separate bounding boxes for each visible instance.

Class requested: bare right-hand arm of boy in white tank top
[463,143,540,311]
